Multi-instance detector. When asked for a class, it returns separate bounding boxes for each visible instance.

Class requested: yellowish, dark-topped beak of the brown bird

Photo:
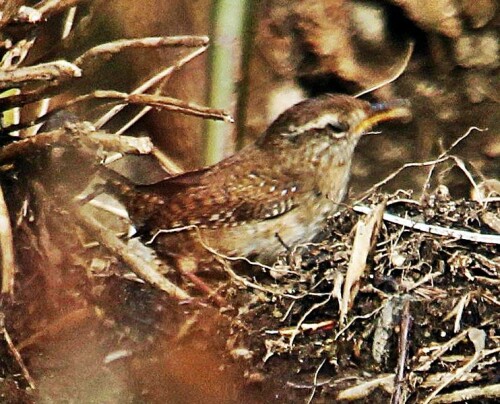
[356,99,412,133]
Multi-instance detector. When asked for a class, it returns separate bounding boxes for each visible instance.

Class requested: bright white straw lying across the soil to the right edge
[353,205,500,244]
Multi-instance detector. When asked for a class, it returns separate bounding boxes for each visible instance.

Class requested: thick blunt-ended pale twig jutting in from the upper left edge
[0,60,82,89]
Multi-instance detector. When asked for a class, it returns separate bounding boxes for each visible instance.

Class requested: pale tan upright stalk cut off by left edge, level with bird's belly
[0,186,16,296]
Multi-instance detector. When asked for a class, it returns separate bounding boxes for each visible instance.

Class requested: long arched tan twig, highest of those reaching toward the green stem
[73,35,209,66]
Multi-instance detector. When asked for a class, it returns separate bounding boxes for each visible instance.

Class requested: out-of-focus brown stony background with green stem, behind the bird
[13,0,499,193]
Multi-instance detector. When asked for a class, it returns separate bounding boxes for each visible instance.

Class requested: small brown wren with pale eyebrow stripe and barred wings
[105,94,411,271]
